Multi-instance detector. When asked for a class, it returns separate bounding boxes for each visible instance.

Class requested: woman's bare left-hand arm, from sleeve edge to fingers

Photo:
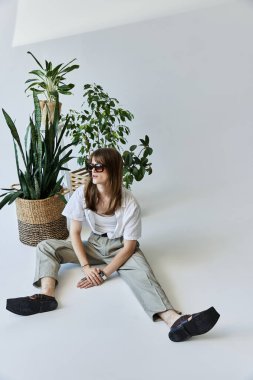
[70,220,103,287]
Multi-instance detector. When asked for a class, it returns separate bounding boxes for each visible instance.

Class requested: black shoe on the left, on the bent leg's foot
[6,294,58,315]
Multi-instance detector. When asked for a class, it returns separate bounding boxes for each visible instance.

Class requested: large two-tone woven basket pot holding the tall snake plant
[15,195,69,246]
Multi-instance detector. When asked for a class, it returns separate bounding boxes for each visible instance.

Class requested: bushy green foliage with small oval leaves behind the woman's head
[66,84,153,188]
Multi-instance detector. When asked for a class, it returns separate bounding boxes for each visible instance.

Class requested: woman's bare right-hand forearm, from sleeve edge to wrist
[103,240,137,277]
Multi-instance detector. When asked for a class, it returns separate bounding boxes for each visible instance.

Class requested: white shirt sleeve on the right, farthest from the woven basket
[123,199,141,240]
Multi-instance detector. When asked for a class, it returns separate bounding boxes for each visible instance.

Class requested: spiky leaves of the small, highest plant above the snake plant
[25,51,79,102]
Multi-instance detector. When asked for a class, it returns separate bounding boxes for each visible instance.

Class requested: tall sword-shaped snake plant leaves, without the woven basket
[0,91,73,209]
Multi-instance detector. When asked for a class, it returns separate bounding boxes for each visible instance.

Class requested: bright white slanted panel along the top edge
[13,0,235,46]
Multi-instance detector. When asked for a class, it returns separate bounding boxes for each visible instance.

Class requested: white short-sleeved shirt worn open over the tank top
[62,186,141,240]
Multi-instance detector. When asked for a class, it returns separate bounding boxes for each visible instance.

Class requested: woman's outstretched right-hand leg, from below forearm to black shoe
[113,245,220,342]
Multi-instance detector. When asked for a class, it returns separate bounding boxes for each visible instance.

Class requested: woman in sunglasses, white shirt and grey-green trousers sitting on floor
[6,148,219,342]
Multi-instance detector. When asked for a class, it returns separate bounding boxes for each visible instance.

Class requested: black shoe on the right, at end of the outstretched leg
[169,307,220,342]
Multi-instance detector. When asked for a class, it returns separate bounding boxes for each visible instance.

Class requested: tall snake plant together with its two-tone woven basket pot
[0,91,72,246]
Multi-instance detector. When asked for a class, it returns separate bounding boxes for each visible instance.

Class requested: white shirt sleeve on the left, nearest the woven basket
[62,186,85,222]
